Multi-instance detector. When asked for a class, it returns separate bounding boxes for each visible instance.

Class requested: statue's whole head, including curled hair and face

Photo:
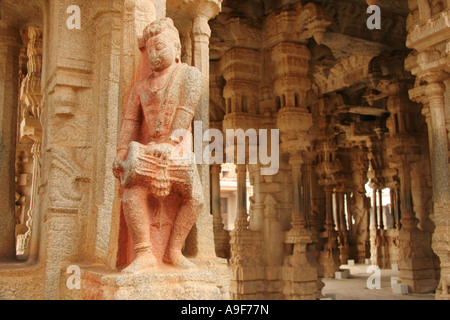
[143,18,181,71]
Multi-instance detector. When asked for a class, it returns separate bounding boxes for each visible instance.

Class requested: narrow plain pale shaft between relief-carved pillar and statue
[84,1,122,263]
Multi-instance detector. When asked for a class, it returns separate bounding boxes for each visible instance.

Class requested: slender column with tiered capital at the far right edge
[402,0,450,300]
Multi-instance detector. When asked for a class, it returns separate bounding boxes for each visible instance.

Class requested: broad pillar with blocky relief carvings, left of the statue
[38,0,100,299]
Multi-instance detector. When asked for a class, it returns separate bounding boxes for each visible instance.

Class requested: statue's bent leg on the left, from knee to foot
[122,187,157,273]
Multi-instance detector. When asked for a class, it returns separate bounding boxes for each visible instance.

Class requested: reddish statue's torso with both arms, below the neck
[119,64,202,149]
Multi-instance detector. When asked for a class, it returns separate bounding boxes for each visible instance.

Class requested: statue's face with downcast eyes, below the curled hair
[147,31,177,71]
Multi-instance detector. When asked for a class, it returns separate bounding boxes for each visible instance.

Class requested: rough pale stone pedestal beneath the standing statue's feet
[61,259,229,300]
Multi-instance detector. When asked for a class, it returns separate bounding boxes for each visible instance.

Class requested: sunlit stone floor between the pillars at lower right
[322,264,434,300]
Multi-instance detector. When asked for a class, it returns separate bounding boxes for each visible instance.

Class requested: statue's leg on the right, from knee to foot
[164,173,204,269]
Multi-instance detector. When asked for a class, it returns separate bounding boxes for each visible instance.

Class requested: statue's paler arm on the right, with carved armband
[171,67,202,143]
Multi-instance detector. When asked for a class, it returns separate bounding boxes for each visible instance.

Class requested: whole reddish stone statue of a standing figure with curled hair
[113,18,203,273]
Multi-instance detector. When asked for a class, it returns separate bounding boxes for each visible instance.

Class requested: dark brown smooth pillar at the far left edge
[0,27,21,260]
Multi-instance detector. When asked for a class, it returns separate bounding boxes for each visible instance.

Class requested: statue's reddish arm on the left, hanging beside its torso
[117,85,142,153]
